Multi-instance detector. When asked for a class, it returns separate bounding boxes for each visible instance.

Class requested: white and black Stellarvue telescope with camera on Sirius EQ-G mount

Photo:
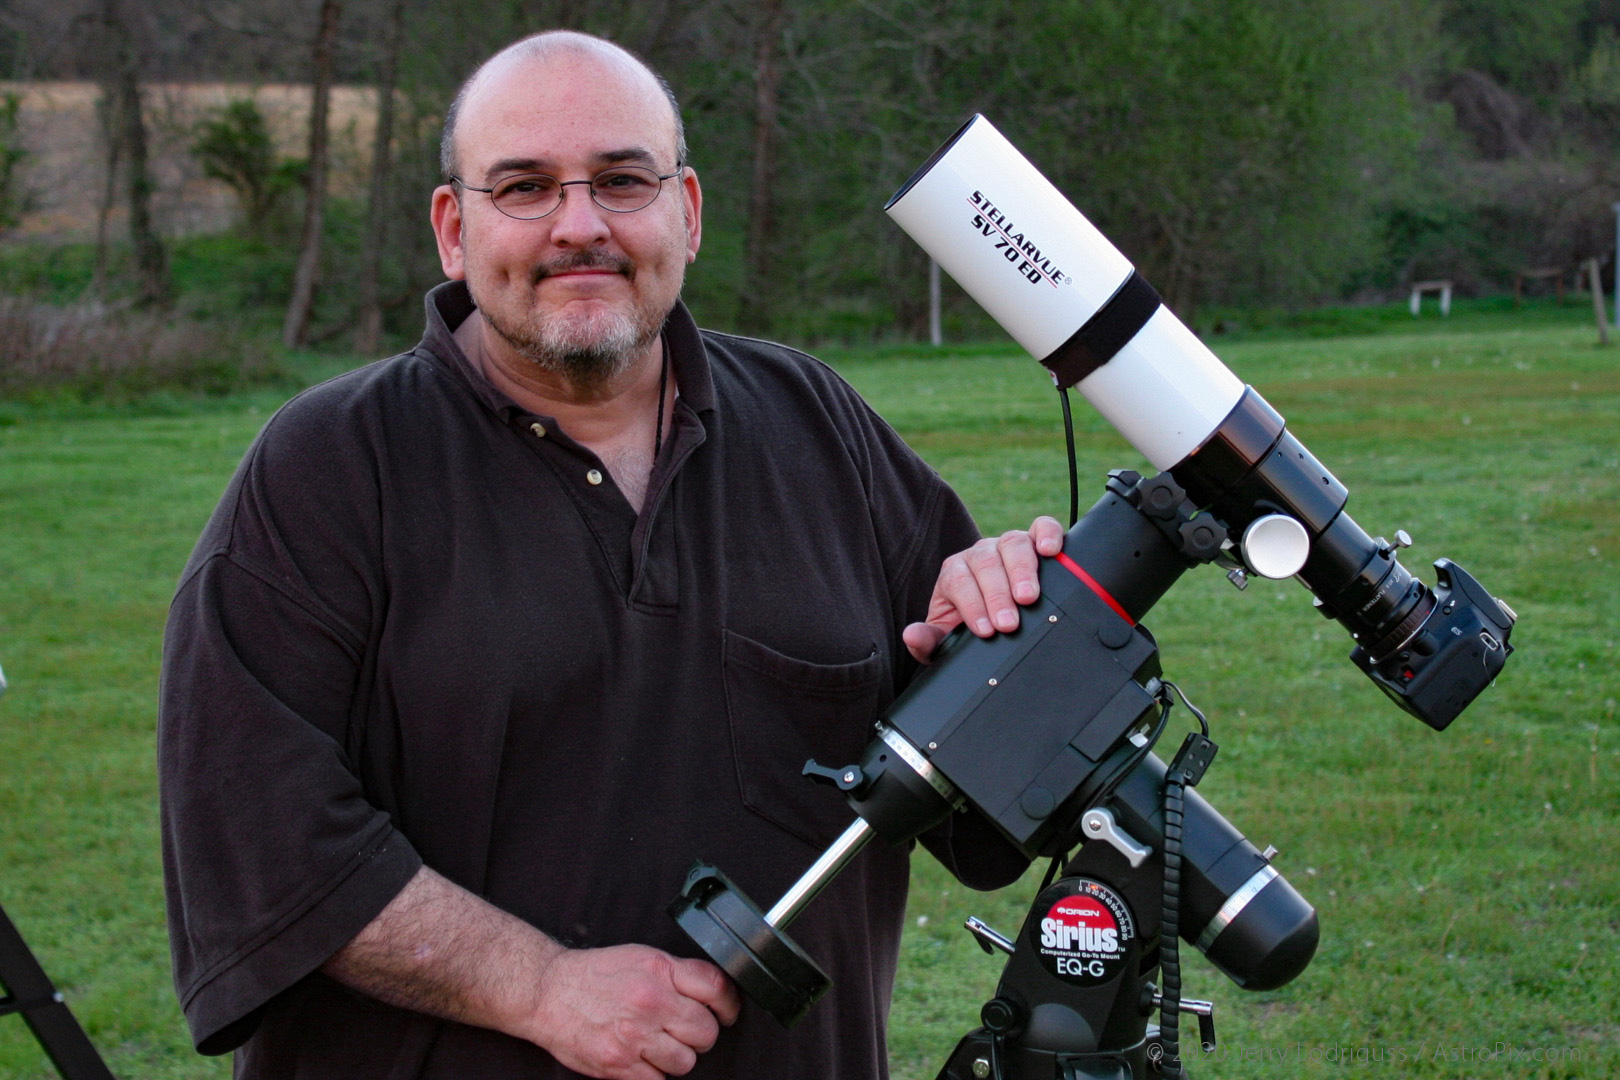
[671,117,1516,1080]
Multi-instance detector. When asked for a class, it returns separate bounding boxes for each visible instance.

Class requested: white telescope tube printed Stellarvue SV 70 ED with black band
[885,115,1243,470]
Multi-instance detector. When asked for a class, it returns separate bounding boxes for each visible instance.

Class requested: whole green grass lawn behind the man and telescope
[0,299,1620,1080]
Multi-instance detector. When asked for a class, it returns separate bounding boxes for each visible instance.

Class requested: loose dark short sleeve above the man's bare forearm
[159,401,421,1052]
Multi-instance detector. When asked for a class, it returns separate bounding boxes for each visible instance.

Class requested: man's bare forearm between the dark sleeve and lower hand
[321,866,564,1040]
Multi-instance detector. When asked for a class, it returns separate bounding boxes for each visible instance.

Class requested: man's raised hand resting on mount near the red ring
[904,515,1063,664]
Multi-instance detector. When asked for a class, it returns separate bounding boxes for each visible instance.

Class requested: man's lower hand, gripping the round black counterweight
[530,946,742,1080]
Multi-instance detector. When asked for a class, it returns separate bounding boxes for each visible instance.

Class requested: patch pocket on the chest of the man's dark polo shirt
[721,630,888,850]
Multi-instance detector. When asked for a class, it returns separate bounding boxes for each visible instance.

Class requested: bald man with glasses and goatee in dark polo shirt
[159,32,1061,1080]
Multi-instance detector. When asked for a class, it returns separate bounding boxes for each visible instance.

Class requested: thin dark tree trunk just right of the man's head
[737,0,786,334]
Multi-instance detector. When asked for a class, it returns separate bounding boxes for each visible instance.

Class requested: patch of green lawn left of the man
[0,406,273,1077]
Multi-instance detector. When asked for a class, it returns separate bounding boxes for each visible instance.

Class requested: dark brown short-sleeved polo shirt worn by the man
[159,283,1019,1080]
